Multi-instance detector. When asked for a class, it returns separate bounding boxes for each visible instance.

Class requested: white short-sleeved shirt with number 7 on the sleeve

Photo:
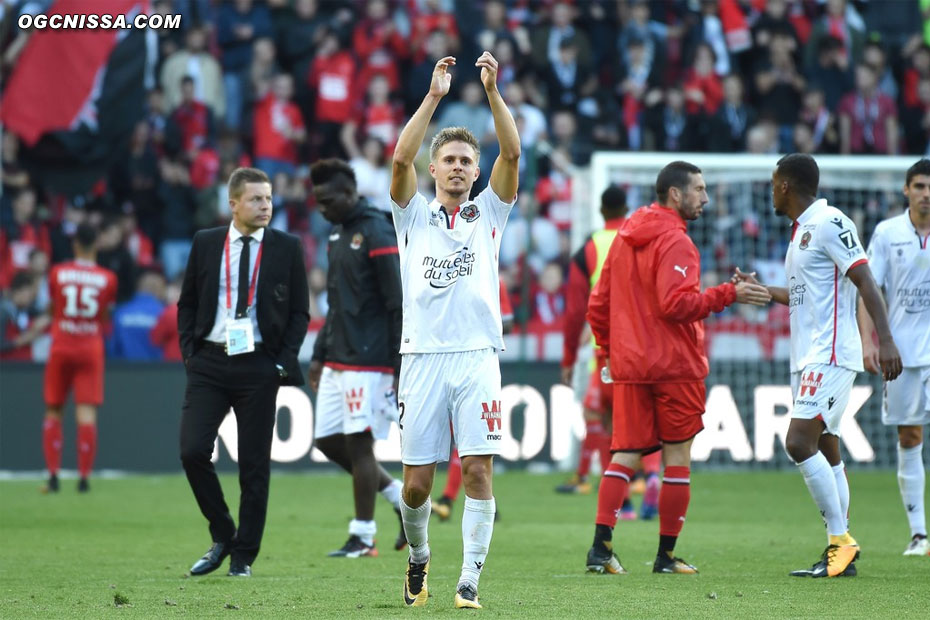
[785,198,868,372]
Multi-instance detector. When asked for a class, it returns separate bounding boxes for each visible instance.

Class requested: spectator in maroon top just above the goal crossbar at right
[839,64,898,155]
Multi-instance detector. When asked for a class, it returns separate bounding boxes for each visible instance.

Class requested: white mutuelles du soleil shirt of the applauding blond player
[391,187,516,353]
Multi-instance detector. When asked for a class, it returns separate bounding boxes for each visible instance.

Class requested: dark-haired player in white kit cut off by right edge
[859,159,930,556]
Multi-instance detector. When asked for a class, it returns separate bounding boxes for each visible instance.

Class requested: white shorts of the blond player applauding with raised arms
[398,349,502,465]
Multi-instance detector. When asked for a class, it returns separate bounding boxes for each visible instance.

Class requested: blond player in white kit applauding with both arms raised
[391,52,520,609]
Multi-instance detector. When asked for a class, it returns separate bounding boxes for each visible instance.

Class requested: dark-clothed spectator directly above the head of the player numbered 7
[756,25,807,151]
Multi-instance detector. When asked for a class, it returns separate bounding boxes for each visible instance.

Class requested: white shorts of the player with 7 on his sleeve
[791,364,856,436]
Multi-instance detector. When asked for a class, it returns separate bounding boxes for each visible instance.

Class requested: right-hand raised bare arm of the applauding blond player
[475,52,520,202]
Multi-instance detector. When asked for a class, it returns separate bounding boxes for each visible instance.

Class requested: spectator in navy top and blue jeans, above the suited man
[216,0,273,129]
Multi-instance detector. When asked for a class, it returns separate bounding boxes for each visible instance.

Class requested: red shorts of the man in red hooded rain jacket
[610,381,707,453]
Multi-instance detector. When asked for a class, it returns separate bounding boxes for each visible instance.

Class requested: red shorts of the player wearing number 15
[45,341,103,407]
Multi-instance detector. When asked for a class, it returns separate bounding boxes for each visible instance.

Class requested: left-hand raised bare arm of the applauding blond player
[391,56,455,208]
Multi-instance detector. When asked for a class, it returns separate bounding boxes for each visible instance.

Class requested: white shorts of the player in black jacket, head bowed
[314,366,398,439]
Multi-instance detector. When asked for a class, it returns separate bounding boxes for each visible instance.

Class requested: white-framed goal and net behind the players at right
[572,152,916,467]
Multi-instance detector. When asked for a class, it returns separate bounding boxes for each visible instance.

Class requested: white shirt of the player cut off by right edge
[869,211,930,367]
